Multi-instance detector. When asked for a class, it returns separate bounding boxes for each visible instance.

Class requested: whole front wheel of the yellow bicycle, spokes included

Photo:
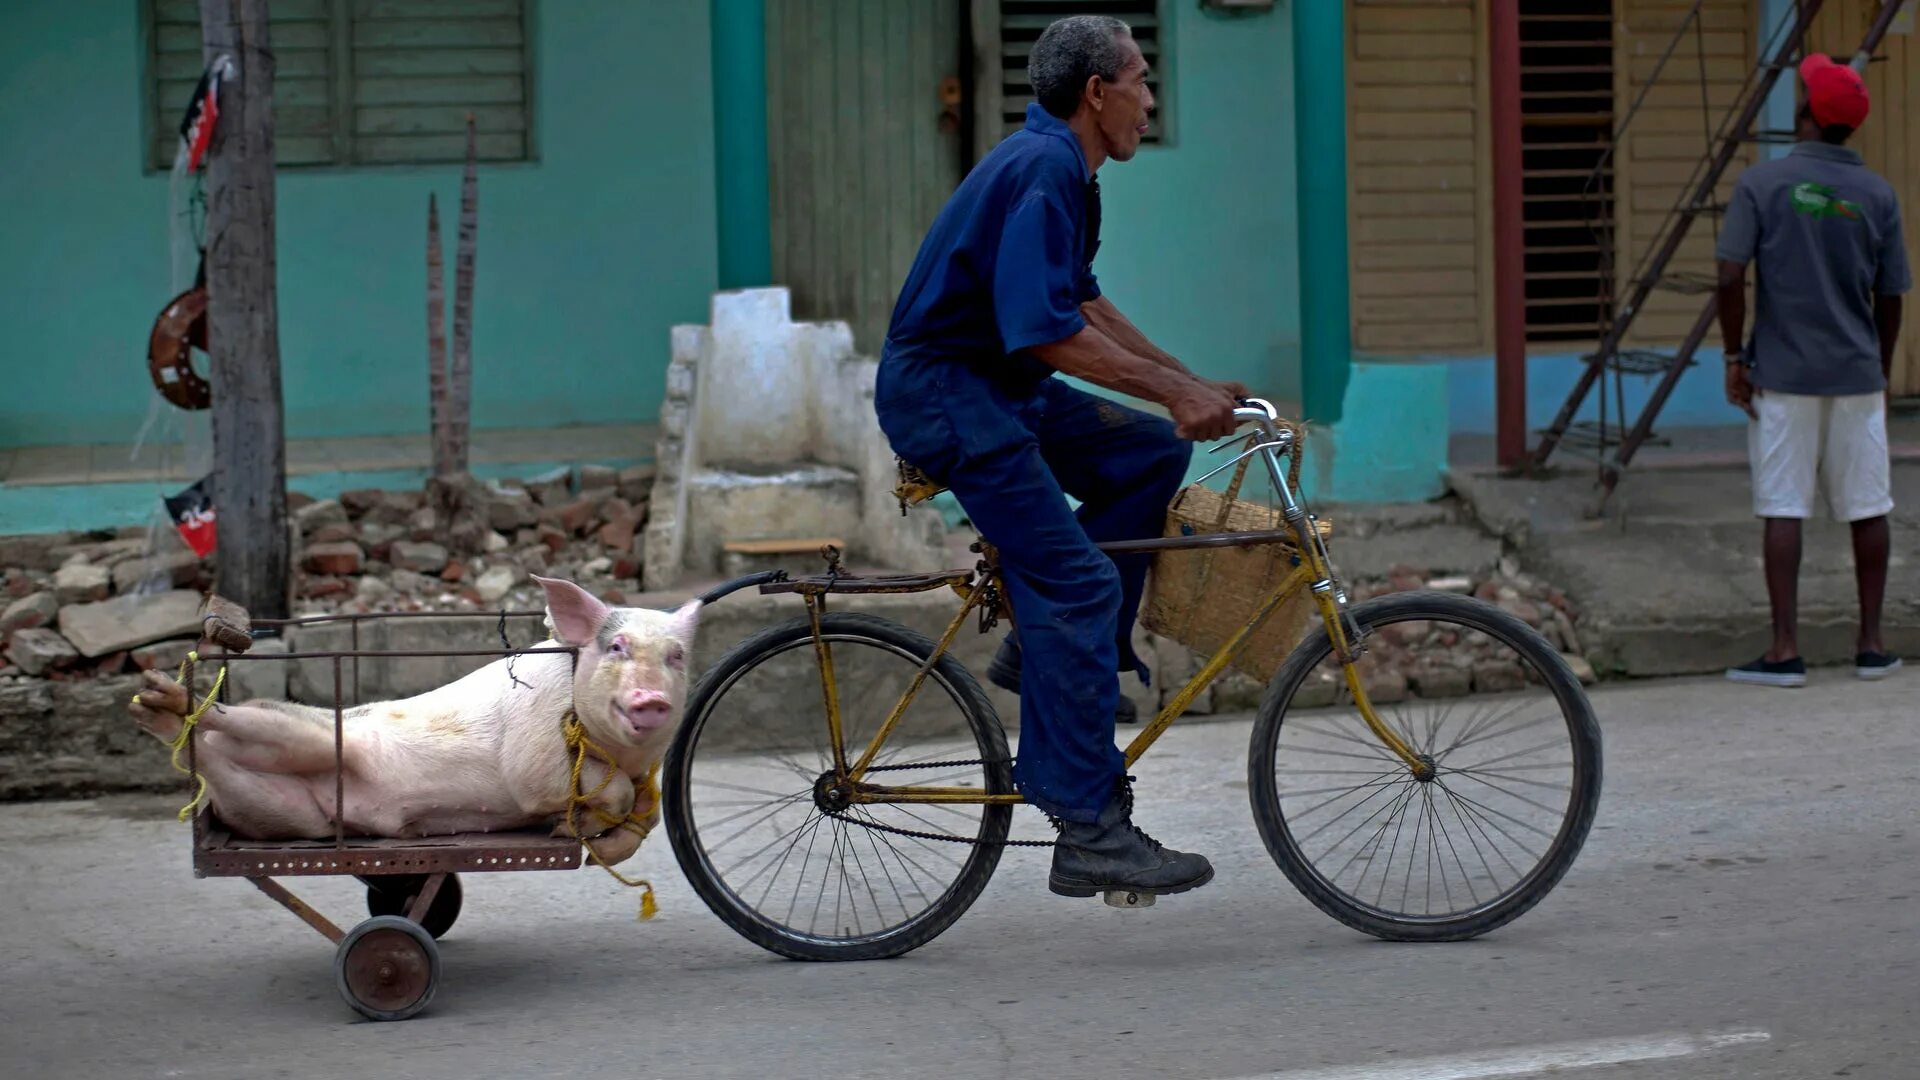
[1248,592,1601,942]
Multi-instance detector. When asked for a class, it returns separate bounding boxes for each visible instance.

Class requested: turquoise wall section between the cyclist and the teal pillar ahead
[1094,2,1300,400]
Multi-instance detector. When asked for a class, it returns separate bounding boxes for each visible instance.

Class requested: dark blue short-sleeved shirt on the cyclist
[887,104,1100,384]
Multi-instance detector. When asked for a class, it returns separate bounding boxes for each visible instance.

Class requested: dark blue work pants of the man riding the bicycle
[874,356,1192,822]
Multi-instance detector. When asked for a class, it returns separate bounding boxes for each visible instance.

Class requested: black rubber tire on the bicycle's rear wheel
[660,613,1014,961]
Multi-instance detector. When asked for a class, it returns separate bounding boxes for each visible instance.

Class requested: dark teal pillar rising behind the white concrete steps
[710,0,774,288]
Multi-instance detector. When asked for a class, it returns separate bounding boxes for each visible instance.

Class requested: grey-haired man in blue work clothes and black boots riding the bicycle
[876,15,1246,896]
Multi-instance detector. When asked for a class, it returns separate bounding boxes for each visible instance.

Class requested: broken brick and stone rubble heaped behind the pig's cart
[0,465,653,680]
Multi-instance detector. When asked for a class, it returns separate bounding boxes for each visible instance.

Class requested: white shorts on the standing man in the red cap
[1747,390,1893,521]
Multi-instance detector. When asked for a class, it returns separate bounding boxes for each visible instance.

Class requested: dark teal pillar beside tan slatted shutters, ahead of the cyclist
[1294,2,1354,423]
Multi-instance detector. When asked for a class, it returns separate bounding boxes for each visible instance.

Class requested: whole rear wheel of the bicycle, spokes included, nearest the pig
[662,613,1014,961]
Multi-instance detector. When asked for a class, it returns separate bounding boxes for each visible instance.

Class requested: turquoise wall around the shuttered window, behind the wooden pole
[0,0,718,448]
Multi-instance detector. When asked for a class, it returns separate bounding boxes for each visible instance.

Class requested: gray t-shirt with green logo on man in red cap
[1715,142,1912,396]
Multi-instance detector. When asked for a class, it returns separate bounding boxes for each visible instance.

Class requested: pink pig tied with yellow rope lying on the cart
[131,577,701,863]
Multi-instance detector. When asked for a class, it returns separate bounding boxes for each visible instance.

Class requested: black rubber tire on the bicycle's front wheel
[1248,590,1601,942]
